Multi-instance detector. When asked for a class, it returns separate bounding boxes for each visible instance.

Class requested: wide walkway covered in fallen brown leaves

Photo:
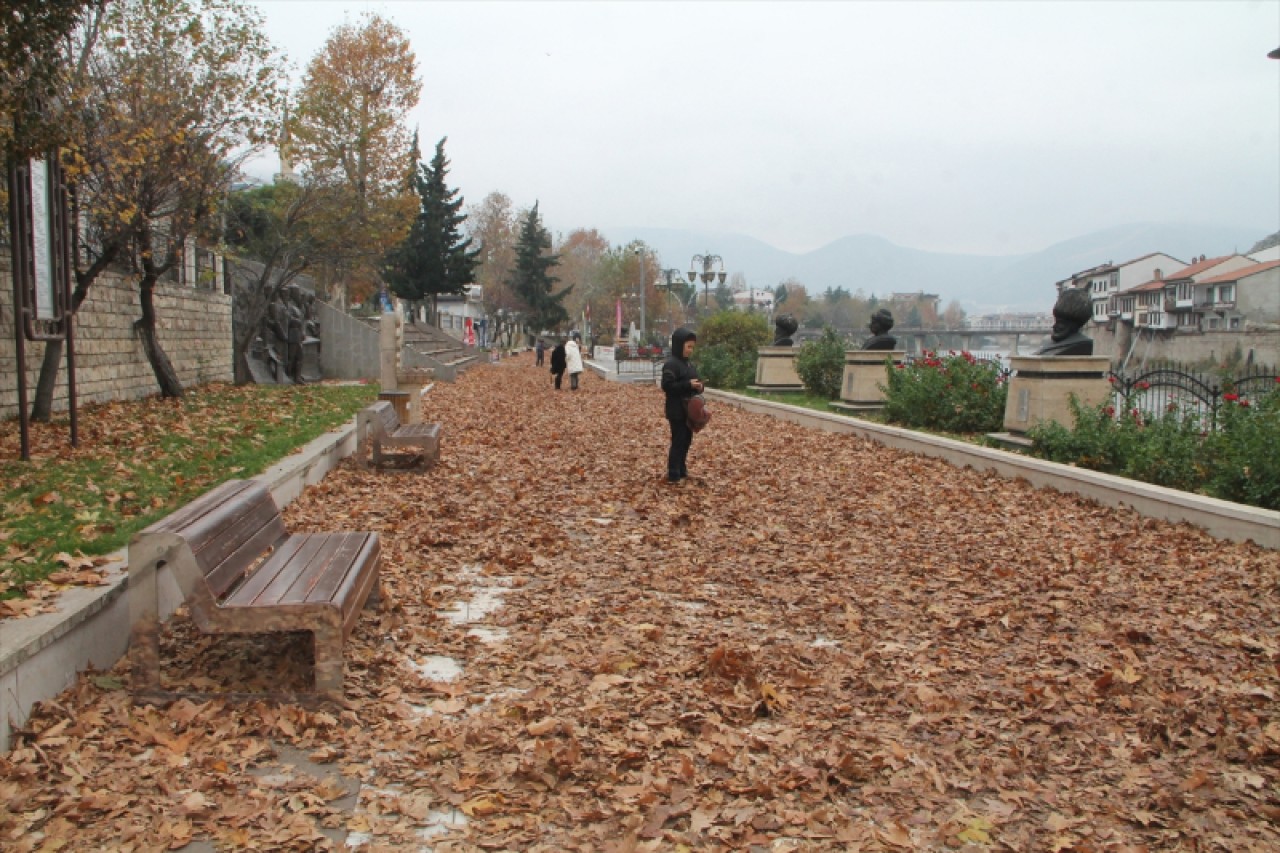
[0,356,1280,852]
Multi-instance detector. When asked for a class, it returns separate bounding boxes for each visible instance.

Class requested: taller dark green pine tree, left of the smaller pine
[383,137,480,318]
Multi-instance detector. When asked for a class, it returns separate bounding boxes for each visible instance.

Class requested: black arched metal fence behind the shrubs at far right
[1110,362,1280,429]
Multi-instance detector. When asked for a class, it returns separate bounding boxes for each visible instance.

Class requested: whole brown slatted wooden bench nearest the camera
[129,480,381,699]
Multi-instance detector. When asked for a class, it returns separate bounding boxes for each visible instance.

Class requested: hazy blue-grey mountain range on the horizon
[604,224,1275,314]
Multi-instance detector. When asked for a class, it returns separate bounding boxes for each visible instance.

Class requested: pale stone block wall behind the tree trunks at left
[0,255,233,418]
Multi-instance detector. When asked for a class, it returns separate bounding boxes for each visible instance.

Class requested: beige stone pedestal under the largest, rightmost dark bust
[1005,356,1111,434]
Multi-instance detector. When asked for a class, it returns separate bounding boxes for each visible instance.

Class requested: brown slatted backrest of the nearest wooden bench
[147,480,288,602]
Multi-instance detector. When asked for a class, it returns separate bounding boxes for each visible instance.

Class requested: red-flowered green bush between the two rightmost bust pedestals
[881,351,1009,433]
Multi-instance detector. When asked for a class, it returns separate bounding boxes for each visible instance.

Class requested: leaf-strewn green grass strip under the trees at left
[0,384,378,598]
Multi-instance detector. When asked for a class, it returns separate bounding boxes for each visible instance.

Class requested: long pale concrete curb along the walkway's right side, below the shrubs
[704,389,1280,549]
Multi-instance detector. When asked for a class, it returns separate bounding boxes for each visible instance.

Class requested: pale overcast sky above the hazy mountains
[241,0,1280,255]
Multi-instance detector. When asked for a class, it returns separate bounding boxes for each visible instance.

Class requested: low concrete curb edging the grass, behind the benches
[0,419,356,752]
